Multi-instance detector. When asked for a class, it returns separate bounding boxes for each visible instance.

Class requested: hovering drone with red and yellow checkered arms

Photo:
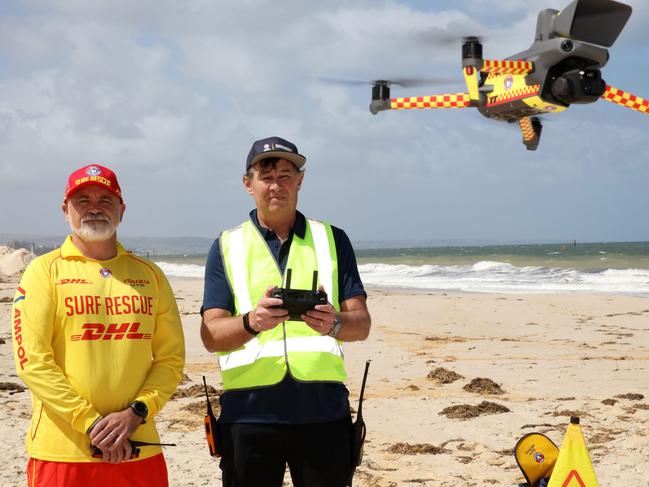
[370,0,649,150]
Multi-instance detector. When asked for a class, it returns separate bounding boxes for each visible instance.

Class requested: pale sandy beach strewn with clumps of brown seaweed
[0,276,649,487]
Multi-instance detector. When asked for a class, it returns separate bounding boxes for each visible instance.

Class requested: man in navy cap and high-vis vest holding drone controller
[201,137,371,487]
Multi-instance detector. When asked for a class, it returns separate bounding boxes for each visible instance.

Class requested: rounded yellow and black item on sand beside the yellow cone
[514,433,559,487]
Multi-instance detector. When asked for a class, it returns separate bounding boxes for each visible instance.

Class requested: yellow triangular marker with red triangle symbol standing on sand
[548,416,599,487]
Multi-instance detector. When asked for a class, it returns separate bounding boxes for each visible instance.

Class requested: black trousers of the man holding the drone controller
[220,416,352,487]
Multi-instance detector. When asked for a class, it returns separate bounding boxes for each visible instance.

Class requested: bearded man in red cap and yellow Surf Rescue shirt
[11,164,185,487]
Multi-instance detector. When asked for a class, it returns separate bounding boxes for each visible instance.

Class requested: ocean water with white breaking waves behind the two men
[154,242,649,297]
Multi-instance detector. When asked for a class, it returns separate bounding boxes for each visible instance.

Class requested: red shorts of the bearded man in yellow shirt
[27,453,169,487]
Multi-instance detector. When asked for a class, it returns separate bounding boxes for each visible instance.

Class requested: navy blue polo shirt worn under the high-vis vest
[201,210,367,424]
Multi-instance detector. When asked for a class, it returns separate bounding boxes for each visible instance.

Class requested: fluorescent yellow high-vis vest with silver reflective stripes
[218,220,346,390]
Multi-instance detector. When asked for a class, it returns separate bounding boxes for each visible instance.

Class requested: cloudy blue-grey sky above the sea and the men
[0,0,649,242]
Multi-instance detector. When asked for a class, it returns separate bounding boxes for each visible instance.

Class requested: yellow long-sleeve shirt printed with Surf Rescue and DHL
[12,237,185,462]
